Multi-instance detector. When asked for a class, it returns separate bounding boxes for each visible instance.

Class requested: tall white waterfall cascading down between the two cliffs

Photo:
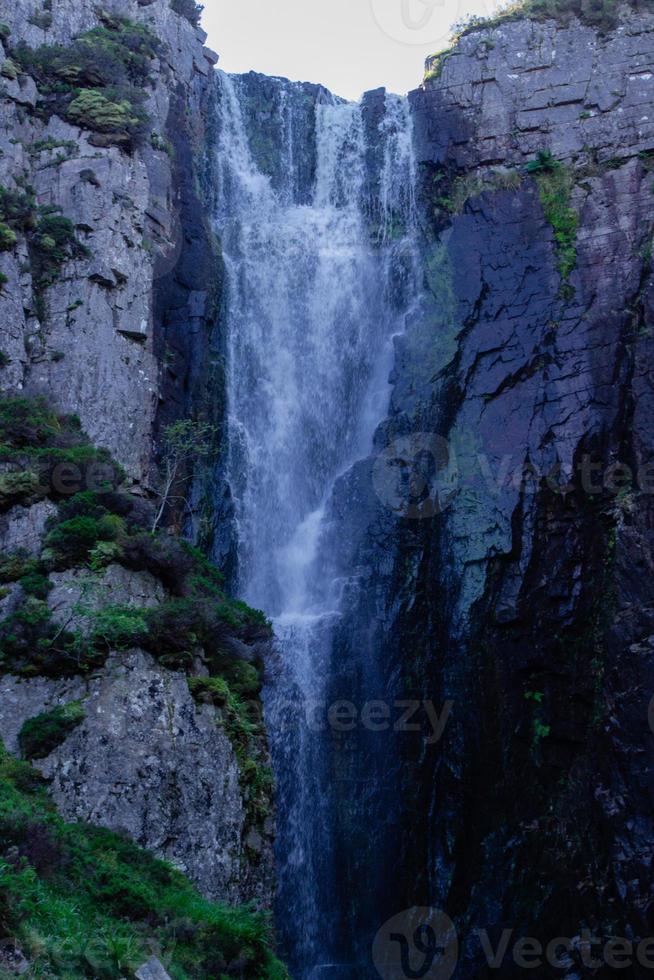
[217,74,418,978]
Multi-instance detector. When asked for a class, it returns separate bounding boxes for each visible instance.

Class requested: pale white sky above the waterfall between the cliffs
[203,0,498,99]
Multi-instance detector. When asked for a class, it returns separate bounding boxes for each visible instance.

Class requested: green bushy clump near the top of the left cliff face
[12,14,160,150]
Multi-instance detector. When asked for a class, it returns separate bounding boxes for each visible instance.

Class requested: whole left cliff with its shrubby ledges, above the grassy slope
[0,0,280,976]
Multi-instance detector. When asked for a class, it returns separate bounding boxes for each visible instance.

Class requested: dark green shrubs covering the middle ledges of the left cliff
[0,390,272,844]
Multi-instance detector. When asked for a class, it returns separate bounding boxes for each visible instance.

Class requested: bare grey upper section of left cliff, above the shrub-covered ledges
[0,0,222,481]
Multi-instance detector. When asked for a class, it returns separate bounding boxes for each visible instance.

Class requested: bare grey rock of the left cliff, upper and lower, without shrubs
[0,0,272,928]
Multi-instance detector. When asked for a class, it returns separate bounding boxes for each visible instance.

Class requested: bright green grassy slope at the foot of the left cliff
[0,748,286,980]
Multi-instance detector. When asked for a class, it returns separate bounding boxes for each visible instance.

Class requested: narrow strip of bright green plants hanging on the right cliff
[525,150,579,282]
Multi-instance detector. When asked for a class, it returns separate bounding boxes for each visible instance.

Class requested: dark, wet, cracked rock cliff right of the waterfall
[334,10,654,964]
